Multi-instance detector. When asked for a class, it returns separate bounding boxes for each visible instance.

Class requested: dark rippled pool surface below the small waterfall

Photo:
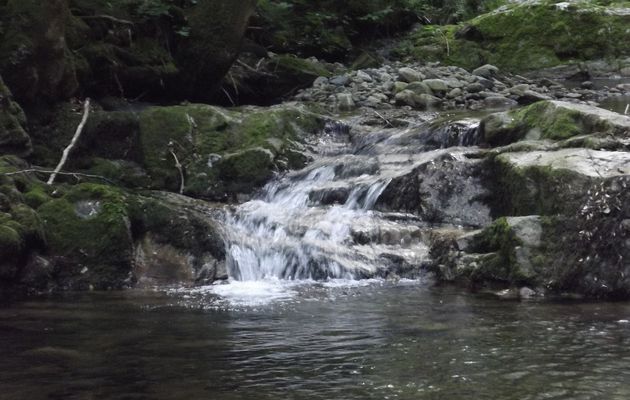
[0,282,630,400]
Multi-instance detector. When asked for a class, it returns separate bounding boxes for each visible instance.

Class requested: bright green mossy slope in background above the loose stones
[395,0,630,72]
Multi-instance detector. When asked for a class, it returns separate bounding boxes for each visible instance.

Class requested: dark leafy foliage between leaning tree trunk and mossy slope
[254,0,501,59]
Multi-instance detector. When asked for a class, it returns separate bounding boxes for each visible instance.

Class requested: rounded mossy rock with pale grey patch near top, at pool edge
[37,184,133,289]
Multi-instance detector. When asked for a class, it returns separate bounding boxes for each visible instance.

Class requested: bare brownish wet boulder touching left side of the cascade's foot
[130,192,227,286]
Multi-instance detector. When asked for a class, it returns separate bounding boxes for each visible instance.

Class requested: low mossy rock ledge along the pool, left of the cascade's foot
[0,166,227,295]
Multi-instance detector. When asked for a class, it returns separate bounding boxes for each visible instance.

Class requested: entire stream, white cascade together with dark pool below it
[0,107,630,400]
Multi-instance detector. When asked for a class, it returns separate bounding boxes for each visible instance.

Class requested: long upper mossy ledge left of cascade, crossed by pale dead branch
[25,103,327,201]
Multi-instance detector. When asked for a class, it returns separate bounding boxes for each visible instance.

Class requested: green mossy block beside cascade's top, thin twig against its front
[140,104,323,199]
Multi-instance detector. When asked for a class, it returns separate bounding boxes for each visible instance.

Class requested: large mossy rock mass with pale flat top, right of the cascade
[430,101,630,299]
